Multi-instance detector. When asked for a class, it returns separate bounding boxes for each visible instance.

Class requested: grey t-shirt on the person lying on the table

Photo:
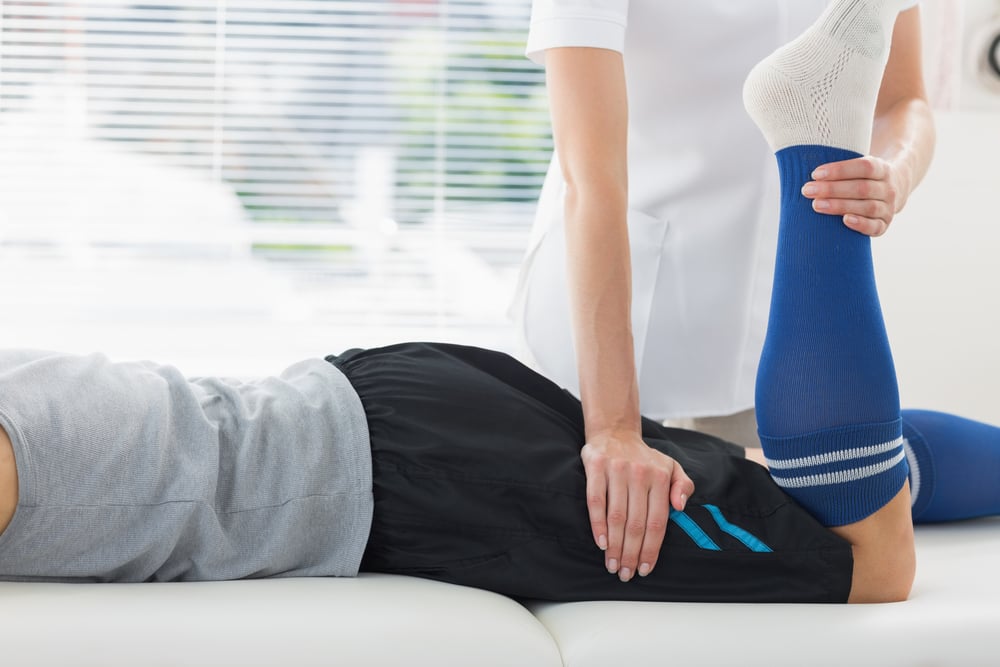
[0,351,373,581]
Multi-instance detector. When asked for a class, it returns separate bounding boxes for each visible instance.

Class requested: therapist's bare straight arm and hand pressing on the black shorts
[545,47,694,581]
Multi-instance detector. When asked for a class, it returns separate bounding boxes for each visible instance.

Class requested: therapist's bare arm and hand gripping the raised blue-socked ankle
[803,7,935,236]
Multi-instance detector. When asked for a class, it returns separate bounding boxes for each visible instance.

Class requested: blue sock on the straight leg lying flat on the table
[903,410,1000,523]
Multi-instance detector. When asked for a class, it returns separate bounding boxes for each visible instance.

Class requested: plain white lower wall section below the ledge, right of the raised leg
[874,105,1000,424]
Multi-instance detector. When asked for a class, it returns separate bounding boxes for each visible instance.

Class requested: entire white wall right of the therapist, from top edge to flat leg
[874,0,1000,424]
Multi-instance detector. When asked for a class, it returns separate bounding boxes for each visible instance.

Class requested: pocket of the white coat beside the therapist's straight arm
[628,209,670,380]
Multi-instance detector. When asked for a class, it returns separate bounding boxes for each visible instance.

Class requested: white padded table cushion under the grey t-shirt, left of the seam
[0,575,562,667]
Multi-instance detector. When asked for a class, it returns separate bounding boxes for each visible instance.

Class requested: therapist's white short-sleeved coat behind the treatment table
[511,0,916,419]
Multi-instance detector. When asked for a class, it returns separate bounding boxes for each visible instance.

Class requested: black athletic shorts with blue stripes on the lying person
[328,343,853,602]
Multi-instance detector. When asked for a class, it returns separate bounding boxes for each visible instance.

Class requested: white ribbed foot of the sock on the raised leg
[743,0,902,155]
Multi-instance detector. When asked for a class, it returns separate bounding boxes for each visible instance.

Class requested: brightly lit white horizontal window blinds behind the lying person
[0,0,552,370]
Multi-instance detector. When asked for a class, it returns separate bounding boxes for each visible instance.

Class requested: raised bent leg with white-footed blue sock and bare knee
[744,0,915,601]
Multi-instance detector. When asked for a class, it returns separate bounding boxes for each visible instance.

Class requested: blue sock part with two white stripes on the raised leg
[756,146,907,526]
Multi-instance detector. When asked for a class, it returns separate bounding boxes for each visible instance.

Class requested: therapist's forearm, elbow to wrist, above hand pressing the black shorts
[565,186,641,440]
